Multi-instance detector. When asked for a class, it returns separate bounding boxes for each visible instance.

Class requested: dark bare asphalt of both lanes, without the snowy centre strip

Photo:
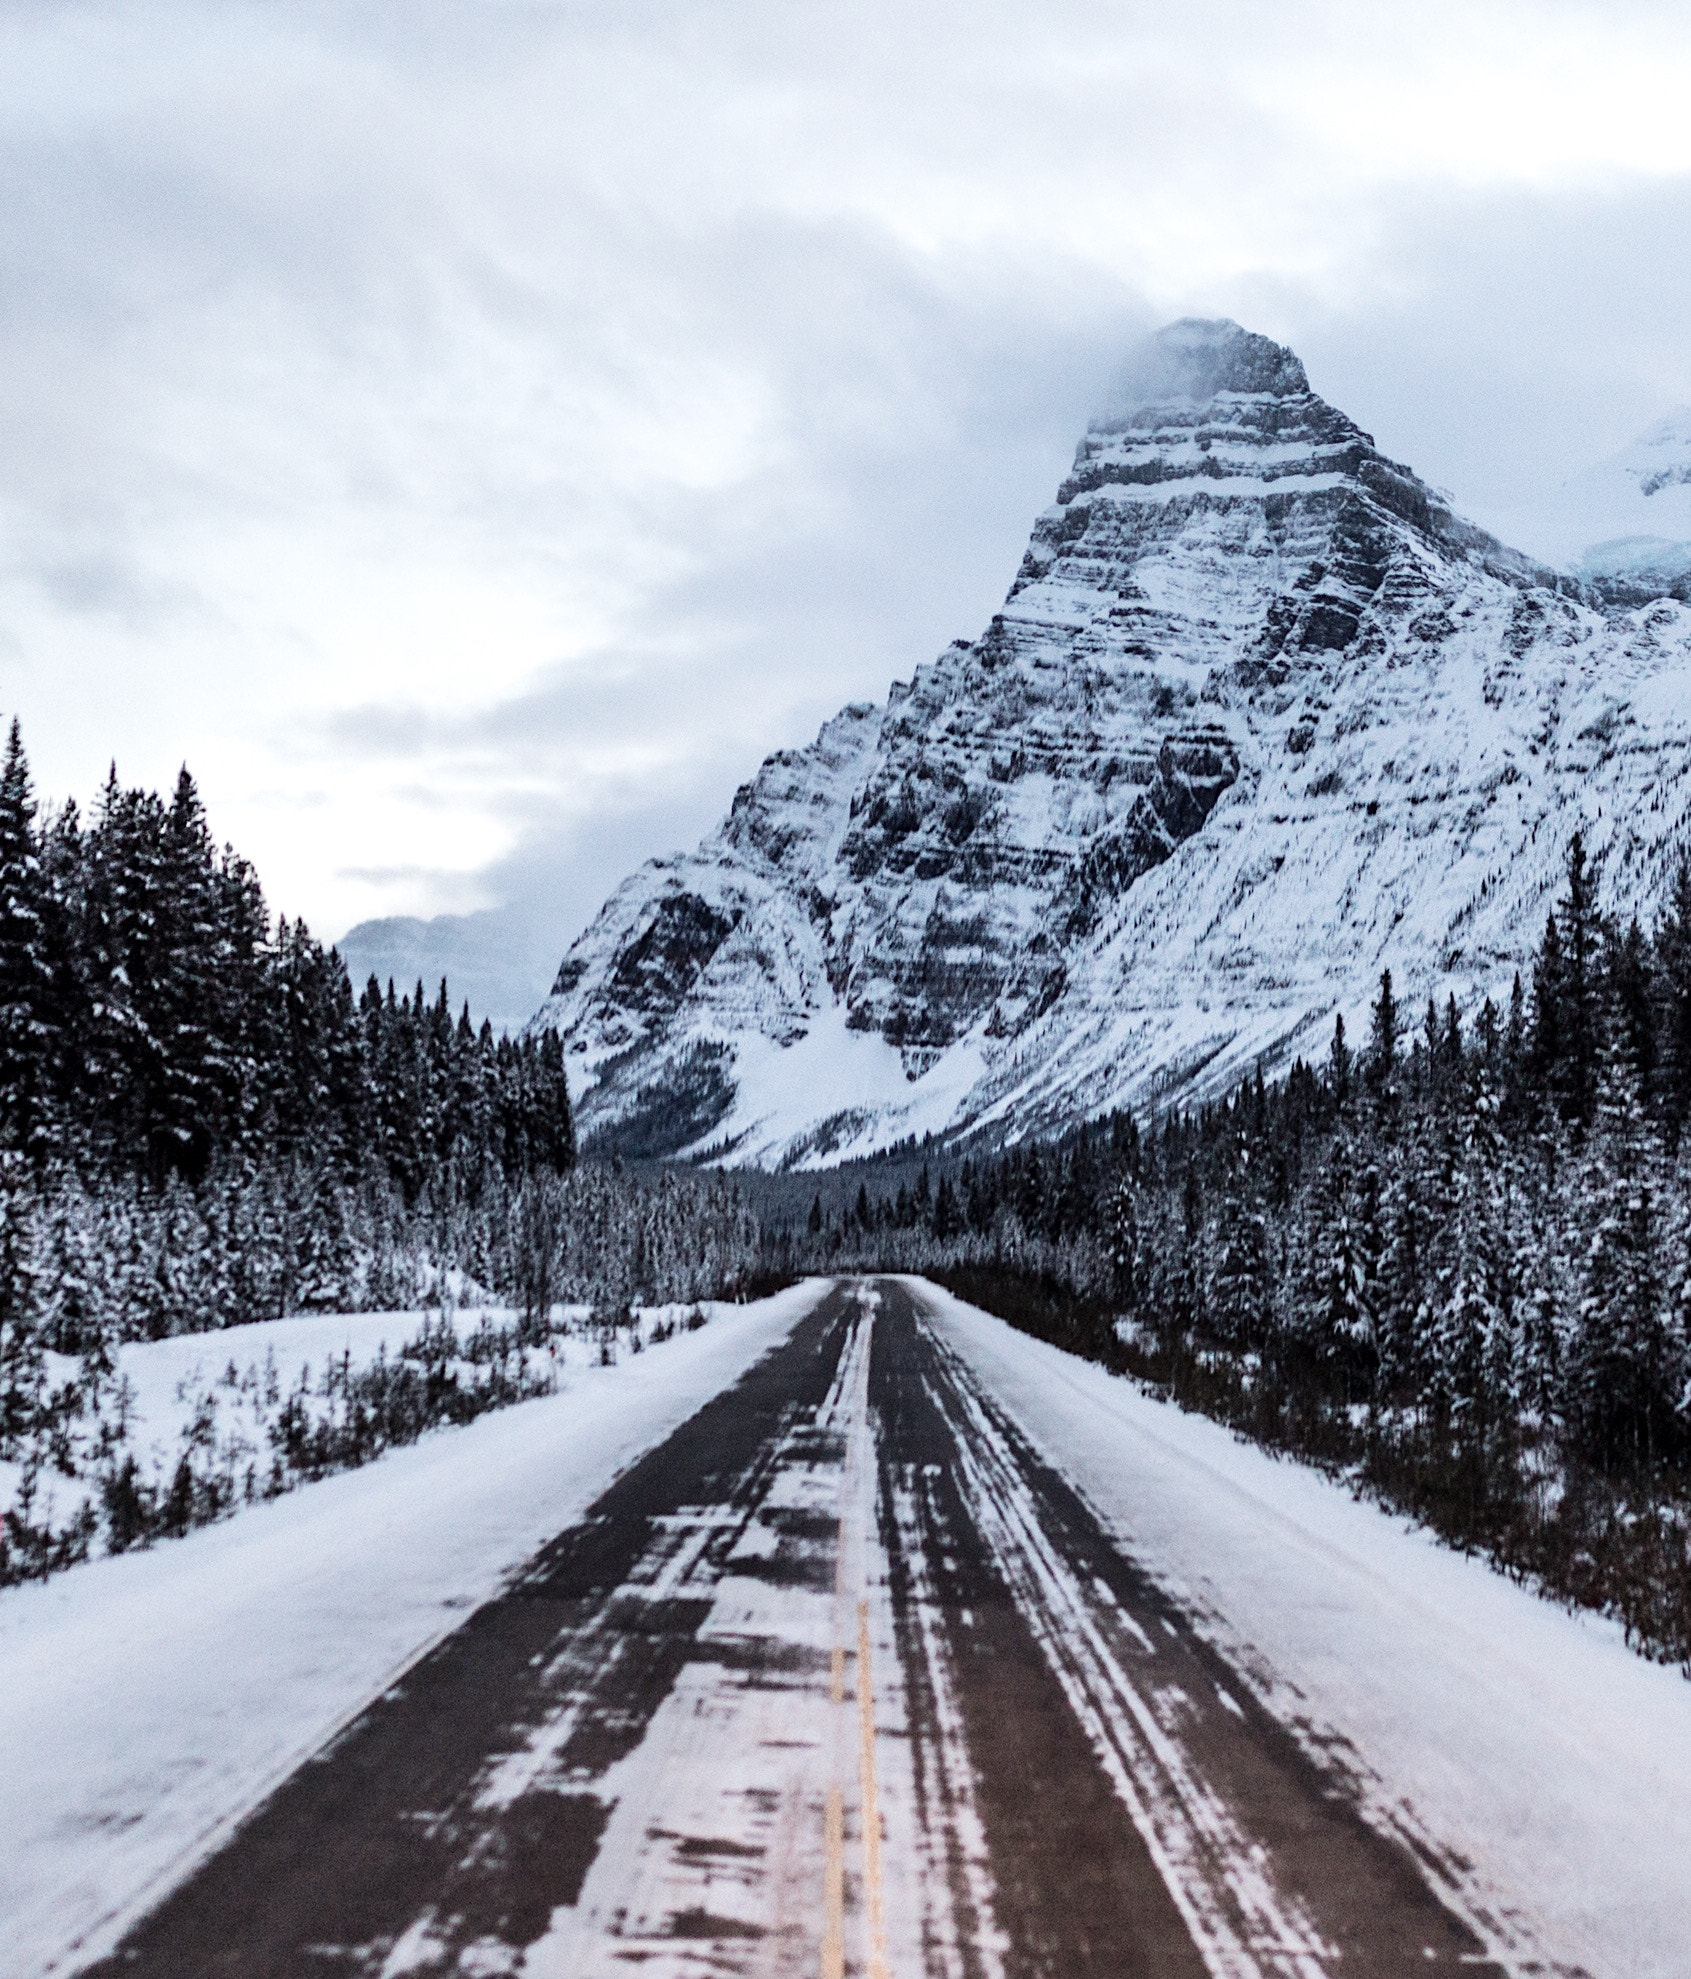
[76,1280,1536,1979]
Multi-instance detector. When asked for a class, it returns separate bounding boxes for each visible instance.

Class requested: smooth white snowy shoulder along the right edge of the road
[913,1280,1691,1979]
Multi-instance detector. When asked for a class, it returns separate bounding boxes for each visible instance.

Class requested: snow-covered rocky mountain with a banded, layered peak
[535,321,1691,1164]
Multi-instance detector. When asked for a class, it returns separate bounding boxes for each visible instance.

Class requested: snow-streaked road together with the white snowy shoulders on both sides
[0,1278,1691,1979]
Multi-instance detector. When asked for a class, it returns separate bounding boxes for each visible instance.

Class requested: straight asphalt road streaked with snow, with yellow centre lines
[79,1280,1501,1979]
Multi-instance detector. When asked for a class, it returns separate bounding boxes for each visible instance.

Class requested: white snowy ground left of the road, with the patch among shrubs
[0,1282,820,1979]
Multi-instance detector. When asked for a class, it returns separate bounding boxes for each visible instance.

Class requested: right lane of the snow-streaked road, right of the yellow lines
[869,1280,1503,1979]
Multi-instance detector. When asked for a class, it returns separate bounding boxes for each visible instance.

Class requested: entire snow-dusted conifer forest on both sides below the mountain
[0,726,1691,1662]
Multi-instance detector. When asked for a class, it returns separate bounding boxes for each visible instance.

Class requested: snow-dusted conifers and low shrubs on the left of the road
[0,724,758,1583]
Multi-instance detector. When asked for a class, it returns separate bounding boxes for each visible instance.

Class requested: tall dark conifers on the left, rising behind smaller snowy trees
[0,720,574,1203]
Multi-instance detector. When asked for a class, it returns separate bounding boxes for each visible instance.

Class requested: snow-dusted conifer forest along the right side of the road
[766,839,1691,1664]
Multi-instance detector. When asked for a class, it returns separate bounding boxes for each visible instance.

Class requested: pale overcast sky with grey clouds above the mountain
[0,0,1691,1005]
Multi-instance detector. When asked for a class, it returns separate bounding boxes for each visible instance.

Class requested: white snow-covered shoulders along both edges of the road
[0,1282,1691,1979]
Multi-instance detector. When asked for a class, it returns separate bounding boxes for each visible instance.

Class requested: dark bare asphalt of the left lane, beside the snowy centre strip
[76,1292,849,1979]
